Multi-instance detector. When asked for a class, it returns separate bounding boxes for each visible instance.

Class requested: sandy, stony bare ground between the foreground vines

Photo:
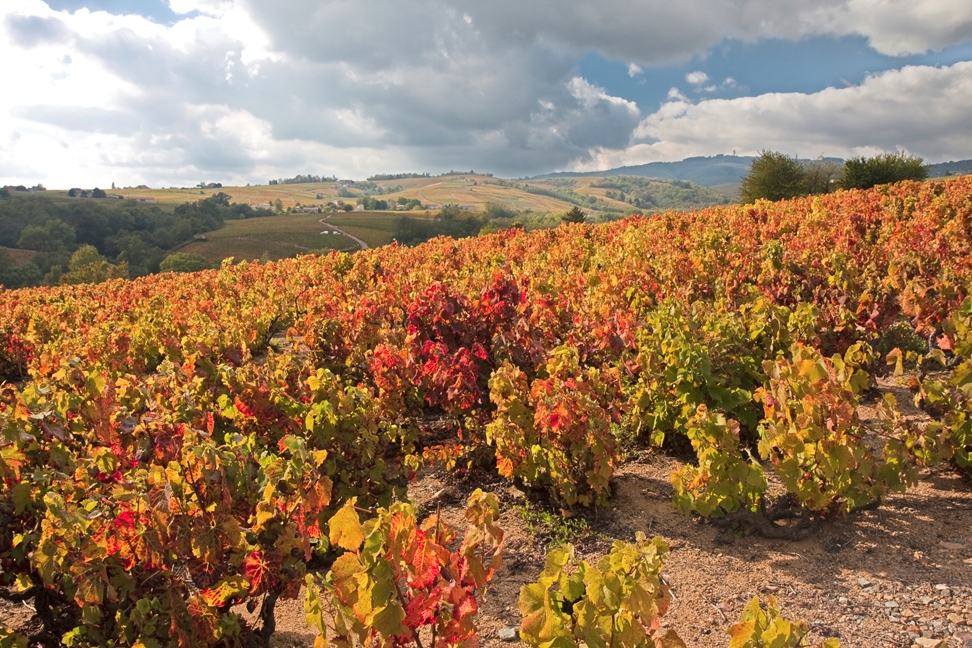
[260,453,972,648]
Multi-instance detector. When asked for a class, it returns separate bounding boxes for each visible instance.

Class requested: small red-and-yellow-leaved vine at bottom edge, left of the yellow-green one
[304,490,503,647]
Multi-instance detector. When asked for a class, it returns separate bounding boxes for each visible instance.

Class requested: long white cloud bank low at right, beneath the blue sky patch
[581,62,972,169]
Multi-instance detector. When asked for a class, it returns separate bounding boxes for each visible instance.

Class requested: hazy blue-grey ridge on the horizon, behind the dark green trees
[531,155,972,187]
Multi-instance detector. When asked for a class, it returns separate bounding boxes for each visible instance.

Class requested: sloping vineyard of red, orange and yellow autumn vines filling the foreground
[0,178,972,648]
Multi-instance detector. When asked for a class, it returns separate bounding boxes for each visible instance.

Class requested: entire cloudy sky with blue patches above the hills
[0,0,972,188]
